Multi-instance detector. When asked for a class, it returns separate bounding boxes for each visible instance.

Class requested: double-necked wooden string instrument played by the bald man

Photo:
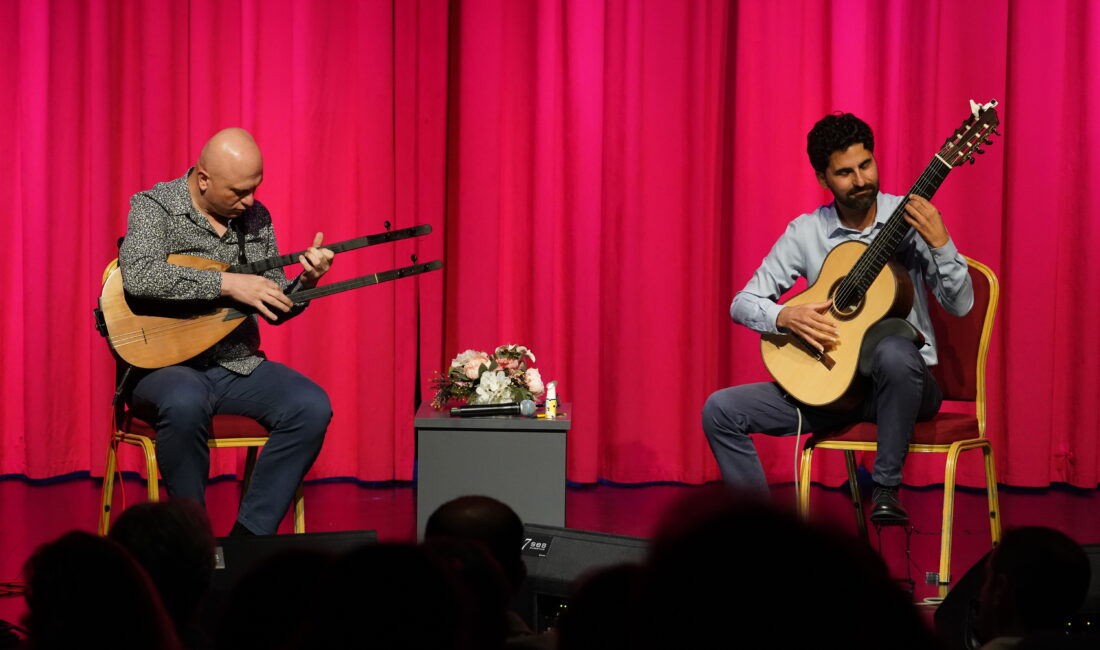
[96,225,443,368]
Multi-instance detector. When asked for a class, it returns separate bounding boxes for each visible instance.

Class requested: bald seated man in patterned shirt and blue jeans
[119,129,333,535]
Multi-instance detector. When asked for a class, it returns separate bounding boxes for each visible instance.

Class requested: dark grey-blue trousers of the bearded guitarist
[703,337,943,492]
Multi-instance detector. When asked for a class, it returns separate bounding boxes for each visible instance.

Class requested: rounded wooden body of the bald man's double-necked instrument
[99,255,248,368]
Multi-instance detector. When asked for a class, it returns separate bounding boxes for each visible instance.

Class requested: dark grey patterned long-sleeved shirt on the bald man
[119,167,306,375]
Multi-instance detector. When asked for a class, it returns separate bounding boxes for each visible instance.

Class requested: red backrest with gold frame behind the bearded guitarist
[928,257,1000,423]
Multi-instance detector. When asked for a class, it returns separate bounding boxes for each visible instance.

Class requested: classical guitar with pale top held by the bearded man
[760,100,1000,408]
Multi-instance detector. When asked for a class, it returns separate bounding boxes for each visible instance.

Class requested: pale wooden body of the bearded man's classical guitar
[760,241,913,409]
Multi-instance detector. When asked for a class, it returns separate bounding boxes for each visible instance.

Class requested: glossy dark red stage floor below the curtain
[0,477,1100,621]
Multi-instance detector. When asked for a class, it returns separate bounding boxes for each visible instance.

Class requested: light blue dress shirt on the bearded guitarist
[729,192,974,366]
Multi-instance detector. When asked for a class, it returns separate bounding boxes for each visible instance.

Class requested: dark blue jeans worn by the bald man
[130,361,332,535]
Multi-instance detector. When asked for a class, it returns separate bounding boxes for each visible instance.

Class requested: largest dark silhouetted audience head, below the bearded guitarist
[638,492,935,649]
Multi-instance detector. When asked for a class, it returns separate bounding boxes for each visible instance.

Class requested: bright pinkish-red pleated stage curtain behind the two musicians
[0,0,1100,487]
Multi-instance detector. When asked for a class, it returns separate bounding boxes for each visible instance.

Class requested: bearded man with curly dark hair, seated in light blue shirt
[703,113,974,524]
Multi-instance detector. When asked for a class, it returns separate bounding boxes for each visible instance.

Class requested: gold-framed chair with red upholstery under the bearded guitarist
[799,257,1001,596]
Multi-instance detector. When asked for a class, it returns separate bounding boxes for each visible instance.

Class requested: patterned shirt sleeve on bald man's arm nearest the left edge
[119,194,221,300]
